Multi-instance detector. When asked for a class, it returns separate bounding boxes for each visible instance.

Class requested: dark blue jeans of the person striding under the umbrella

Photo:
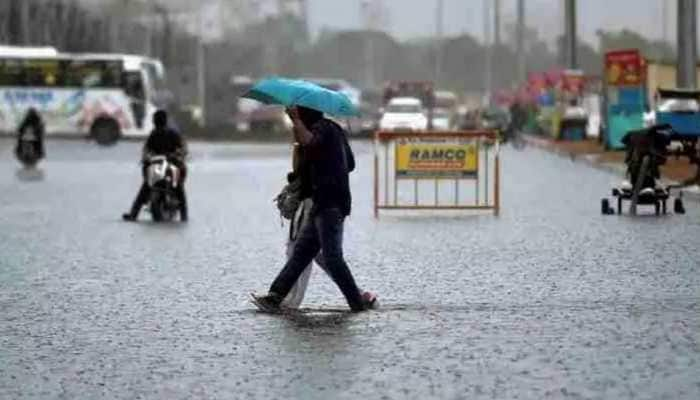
[270,208,364,311]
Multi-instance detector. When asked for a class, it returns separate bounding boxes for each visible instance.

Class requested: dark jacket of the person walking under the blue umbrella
[303,118,355,216]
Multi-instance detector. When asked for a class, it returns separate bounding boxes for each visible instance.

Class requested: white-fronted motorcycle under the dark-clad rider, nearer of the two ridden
[146,155,180,222]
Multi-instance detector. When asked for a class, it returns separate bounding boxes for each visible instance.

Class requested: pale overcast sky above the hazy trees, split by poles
[308,0,676,44]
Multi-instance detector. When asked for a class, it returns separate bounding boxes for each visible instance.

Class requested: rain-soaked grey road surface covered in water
[0,140,700,399]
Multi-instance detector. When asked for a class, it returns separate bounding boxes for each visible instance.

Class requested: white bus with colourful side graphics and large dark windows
[0,46,165,144]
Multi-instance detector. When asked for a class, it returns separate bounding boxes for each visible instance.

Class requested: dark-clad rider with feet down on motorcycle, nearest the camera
[122,110,187,222]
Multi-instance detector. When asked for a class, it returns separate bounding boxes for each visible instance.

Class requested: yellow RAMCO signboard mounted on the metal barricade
[395,142,479,179]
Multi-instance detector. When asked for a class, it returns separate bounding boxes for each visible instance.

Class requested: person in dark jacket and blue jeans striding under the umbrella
[253,106,374,312]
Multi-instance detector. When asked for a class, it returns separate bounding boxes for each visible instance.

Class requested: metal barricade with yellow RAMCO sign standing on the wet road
[374,131,500,218]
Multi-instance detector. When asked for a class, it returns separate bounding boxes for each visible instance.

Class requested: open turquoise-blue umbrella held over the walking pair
[243,77,359,117]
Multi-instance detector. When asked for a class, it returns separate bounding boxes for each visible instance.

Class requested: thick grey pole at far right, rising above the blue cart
[676,0,698,89]
